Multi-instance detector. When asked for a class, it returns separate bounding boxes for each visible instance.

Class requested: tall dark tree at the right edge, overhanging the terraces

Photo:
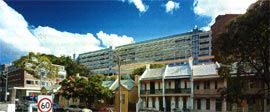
[213,0,270,102]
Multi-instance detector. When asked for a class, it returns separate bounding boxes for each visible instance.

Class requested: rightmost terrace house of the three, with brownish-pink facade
[193,64,227,112]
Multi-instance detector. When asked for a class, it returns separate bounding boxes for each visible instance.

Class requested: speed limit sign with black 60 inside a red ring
[37,98,52,112]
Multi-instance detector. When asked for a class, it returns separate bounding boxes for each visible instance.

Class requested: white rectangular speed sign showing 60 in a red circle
[37,95,53,112]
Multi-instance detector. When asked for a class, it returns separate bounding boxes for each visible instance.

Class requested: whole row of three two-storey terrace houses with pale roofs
[137,61,226,112]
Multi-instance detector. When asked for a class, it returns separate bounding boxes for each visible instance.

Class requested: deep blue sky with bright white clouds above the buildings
[0,0,255,64]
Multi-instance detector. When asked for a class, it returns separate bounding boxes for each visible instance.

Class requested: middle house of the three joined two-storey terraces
[164,65,193,111]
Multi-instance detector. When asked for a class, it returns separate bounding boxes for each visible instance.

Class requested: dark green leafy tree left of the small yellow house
[60,75,113,106]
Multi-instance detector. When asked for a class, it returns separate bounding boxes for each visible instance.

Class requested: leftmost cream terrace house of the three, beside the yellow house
[137,66,165,111]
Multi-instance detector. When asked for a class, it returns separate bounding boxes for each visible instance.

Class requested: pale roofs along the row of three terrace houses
[140,63,219,80]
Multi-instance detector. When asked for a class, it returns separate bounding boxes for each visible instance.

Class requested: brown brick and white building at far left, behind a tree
[0,65,66,103]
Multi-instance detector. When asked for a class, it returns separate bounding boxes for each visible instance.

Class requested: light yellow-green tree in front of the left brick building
[13,52,58,78]
